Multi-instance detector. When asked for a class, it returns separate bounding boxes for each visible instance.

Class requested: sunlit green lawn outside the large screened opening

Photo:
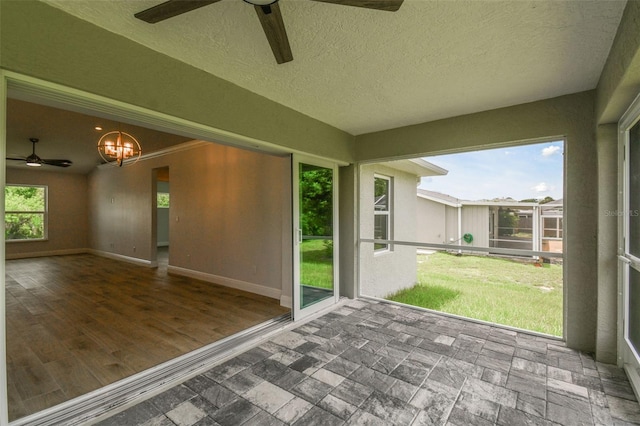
[387,253,562,336]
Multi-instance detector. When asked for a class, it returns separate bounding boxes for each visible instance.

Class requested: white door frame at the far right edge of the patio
[617,90,640,395]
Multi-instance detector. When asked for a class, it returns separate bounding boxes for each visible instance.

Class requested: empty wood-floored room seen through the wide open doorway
[5,98,290,420]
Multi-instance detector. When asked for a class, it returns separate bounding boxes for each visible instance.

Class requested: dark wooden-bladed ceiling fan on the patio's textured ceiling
[134,0,404,64]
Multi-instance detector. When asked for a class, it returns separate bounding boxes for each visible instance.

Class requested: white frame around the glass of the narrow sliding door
[291,154,340,321]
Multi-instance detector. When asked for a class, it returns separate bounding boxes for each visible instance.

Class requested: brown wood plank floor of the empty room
[6,251,289,420]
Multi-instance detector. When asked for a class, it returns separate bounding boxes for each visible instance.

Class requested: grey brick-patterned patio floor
[100,299,640,426]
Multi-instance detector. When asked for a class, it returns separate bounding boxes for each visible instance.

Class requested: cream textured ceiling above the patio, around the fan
[46,0,626,135]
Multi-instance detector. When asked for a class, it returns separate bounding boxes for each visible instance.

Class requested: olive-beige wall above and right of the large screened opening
[356,91,598,352]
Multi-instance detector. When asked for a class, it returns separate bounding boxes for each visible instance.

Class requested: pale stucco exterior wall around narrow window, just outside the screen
[360,164,417,297]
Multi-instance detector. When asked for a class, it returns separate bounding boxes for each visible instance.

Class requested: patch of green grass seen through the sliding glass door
[300,240,333,288]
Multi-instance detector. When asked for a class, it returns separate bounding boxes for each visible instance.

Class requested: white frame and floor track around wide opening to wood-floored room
[0,68,348,426]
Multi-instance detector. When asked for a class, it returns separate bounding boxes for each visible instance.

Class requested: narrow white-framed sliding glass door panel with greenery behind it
[293,156,339,320]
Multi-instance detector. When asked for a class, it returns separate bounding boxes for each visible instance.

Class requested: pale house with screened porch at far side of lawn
[417,189,562,253]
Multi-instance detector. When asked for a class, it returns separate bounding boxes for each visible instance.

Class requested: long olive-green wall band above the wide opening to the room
[0,1,353,162]
